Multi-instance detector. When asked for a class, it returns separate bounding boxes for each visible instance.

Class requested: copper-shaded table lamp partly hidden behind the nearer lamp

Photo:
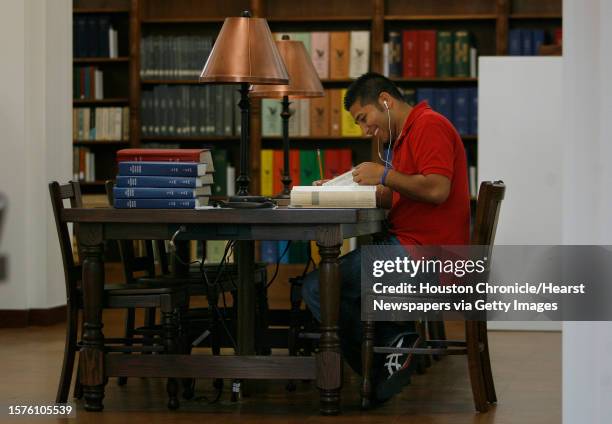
[251,35,325,199]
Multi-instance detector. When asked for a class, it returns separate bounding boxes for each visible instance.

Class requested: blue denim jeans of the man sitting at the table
[302,236,414,374]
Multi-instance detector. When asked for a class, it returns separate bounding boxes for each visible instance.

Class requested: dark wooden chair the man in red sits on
[361,181,506,412]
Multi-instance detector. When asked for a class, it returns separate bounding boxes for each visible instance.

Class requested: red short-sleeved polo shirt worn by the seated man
[388,101,470,245]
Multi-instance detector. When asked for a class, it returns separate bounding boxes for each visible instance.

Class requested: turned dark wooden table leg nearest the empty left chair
[78,224,107,411]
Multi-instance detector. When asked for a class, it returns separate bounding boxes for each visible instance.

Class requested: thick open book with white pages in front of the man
[289,170,376,208]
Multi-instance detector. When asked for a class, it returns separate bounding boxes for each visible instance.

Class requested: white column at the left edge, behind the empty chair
[0,0,72,309]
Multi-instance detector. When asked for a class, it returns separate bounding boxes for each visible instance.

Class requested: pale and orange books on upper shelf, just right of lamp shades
[274,31,370,79]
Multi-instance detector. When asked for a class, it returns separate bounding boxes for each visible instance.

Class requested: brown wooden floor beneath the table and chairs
[0,311,561,424]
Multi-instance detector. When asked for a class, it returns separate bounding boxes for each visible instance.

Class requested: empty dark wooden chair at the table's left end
[49,181,188,409]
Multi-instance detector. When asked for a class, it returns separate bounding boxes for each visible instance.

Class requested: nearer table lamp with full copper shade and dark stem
[200,11,289,203]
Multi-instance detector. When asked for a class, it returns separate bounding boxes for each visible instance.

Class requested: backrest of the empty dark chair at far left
[49,181,83,305]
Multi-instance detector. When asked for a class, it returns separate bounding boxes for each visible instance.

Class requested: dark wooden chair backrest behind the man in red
[471,181,506,256]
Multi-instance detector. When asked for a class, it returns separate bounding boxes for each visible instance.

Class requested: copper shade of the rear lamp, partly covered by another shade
[250,35,324,99]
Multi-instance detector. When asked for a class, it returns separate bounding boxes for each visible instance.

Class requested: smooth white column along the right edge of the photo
[563,0,612,424]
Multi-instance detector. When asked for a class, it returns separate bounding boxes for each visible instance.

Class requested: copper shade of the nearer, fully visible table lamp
[200,17,289,84]
